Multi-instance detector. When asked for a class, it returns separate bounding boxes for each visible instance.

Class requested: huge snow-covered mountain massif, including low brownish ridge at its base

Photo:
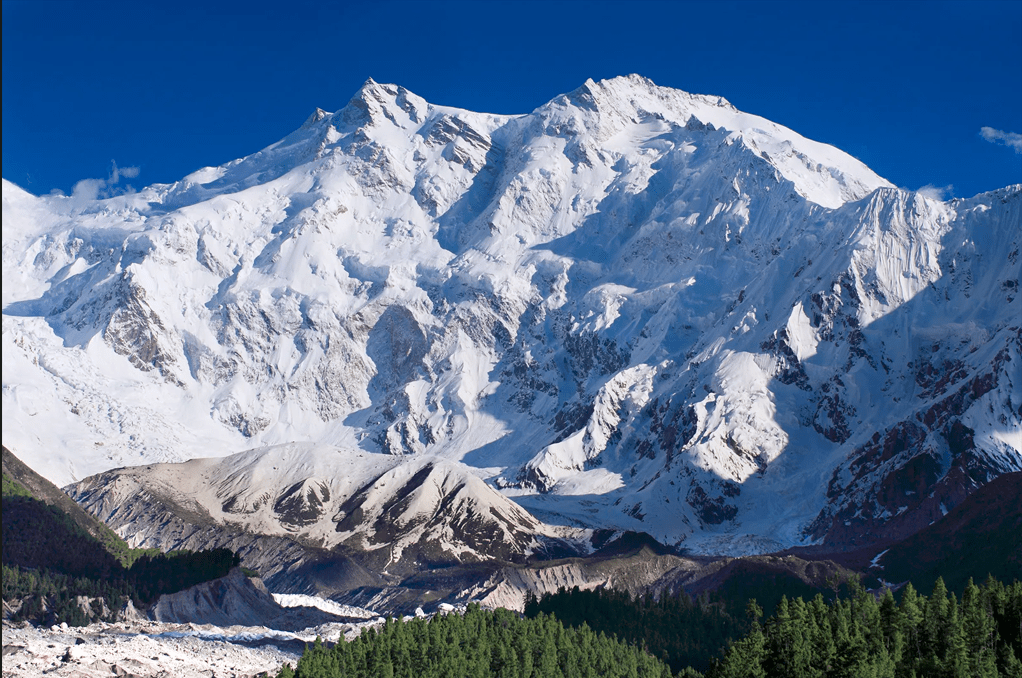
[3,76,1022,561]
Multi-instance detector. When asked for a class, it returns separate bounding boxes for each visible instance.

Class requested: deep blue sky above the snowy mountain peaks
[2,0,1022,197]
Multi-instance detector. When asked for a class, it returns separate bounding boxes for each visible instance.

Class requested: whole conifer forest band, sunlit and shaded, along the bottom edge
[277,577,1022,678]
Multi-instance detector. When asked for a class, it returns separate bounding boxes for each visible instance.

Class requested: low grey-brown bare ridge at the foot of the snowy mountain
[72,445,572,593]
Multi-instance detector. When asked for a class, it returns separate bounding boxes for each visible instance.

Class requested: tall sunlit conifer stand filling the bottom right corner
[708,577,1022,678]
